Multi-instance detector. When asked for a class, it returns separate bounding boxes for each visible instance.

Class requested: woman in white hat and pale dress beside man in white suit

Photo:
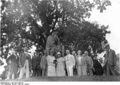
[56,52,65,76]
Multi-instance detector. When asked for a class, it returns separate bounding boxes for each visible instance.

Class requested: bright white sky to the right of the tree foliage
[87,0,120,53]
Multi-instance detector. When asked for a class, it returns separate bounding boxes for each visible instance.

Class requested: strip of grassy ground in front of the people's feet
[5,76,120,82]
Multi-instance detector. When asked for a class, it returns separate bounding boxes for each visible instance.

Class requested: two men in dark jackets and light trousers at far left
[2,47,31,80]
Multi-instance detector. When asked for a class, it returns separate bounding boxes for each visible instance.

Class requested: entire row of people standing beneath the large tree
[0,41,120,79]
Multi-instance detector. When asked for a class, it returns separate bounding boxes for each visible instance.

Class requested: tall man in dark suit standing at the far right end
[103,43,117,76]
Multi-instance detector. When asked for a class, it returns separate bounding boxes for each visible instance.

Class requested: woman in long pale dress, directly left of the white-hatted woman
[47,51,56,77]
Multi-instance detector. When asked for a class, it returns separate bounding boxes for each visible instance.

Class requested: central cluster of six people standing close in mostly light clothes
[46,50,93,76]
